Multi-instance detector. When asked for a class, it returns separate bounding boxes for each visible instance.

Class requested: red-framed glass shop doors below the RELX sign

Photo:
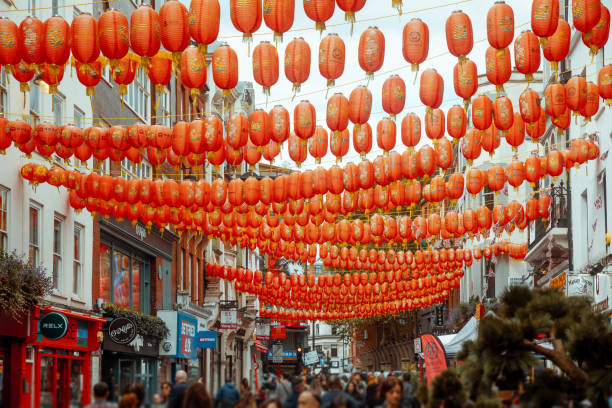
[40,354,83,408]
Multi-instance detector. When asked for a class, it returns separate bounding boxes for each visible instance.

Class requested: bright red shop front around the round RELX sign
[26,306,106,408]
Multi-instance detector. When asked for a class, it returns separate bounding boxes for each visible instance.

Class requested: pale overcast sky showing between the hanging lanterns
[182,0,531,169]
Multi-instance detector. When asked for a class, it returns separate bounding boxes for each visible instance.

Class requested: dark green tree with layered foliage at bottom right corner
[457,287,612,406]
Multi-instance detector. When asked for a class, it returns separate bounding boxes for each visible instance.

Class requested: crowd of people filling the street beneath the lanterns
[87,371,419,408]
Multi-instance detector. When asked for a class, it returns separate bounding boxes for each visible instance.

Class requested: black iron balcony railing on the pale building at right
[528,182,570,248]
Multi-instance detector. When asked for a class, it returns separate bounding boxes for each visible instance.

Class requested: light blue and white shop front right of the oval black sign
[157,310,202,381]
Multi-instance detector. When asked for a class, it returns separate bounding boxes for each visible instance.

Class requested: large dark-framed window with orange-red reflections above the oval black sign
[99,243,150,313]
